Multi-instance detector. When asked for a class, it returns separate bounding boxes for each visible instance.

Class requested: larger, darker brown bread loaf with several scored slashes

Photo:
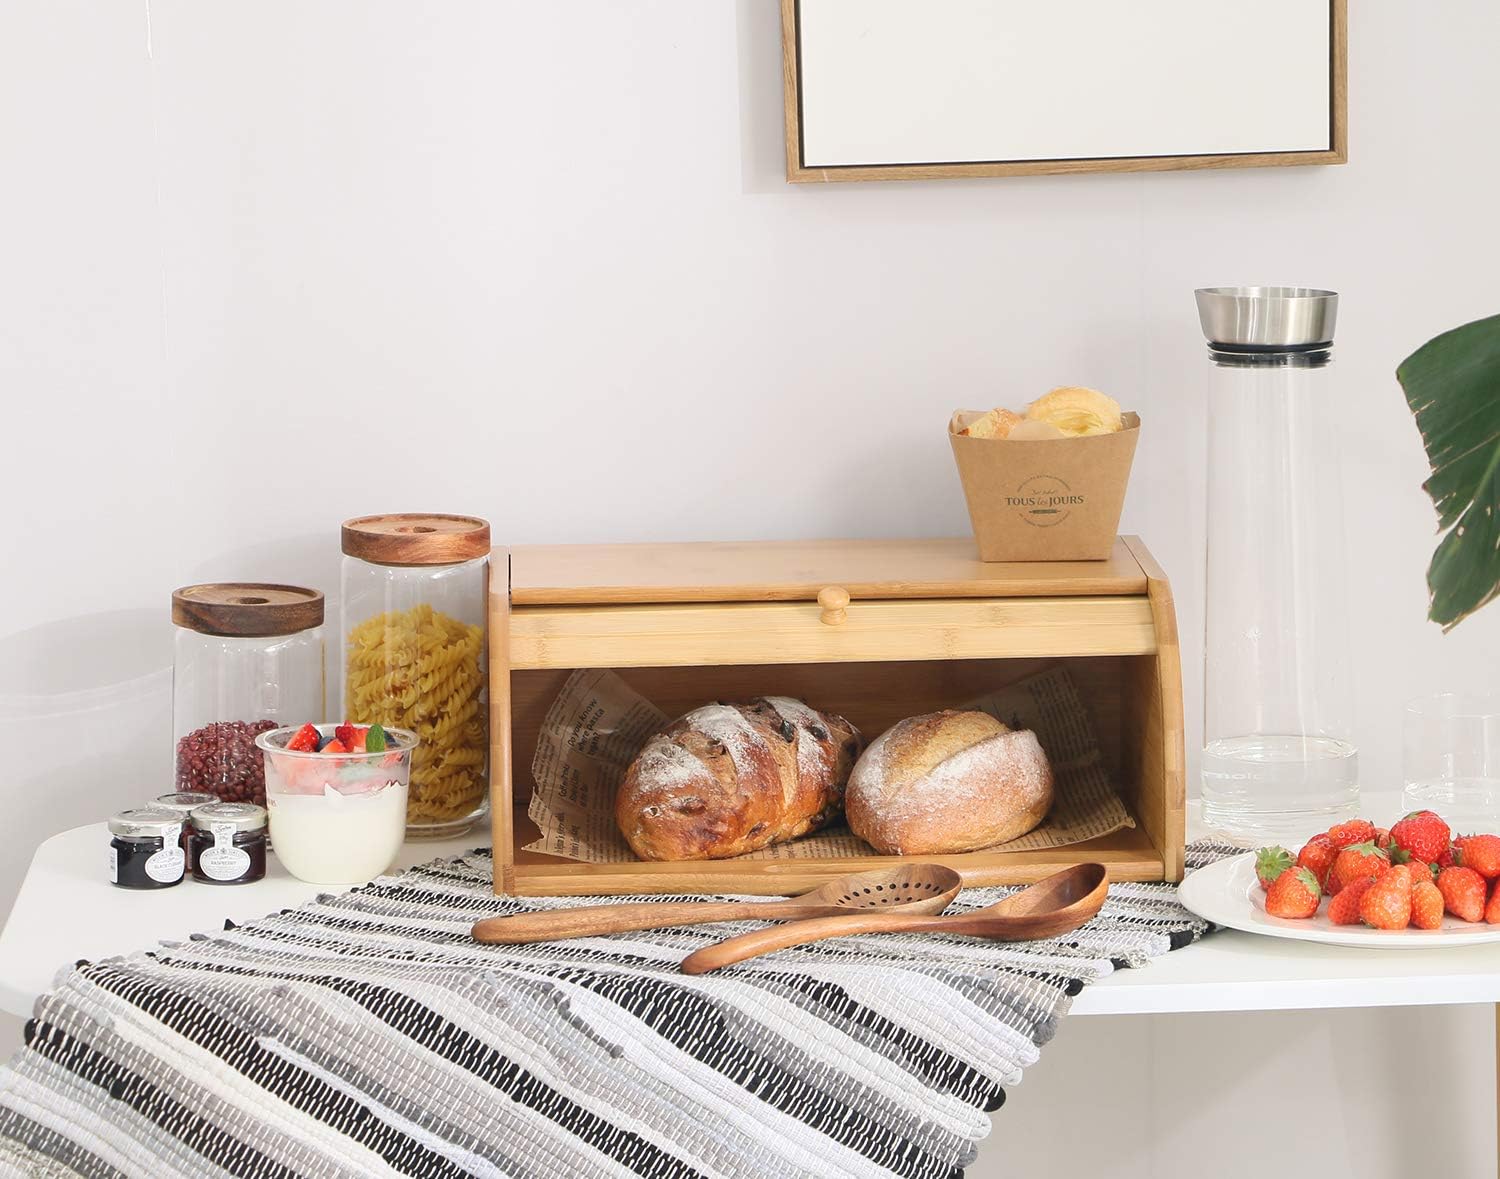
[615,696,863,860]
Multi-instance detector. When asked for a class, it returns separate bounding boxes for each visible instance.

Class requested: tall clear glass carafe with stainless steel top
[1197,287,1359,846]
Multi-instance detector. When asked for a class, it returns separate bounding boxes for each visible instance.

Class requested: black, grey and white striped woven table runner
[0,843,1239,1179]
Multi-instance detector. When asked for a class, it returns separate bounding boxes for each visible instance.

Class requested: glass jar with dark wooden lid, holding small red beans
[173,582,326,806]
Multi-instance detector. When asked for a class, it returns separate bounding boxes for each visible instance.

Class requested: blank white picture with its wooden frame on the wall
[782,0,1347,183]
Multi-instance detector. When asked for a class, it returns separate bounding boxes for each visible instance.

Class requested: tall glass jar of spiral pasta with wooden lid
[341,515,489,837]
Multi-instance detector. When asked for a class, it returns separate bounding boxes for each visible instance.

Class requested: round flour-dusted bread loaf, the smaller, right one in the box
[845,710,1052,855]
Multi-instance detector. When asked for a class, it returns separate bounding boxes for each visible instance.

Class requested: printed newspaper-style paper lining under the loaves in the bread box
[527,668,1136,864]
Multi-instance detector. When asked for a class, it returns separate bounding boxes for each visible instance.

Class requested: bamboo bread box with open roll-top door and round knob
[489,537,1184,896]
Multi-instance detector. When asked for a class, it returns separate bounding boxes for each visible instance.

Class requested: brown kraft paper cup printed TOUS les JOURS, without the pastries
[948,410,1140,561]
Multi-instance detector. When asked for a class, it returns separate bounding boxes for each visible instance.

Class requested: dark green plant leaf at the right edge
[1397,307,1500,630]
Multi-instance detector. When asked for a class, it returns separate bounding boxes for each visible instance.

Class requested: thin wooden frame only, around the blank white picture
[782,0,1349,185]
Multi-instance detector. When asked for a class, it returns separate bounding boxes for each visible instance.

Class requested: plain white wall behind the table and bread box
[0,0,1500,1175]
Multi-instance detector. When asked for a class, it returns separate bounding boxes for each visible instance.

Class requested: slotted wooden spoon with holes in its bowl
[473,864,963,945]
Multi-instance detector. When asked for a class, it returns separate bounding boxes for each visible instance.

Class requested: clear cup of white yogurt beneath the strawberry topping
[255,725,417,885]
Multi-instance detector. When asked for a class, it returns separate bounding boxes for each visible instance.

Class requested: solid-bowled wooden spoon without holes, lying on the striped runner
[681,864,1110,975]
